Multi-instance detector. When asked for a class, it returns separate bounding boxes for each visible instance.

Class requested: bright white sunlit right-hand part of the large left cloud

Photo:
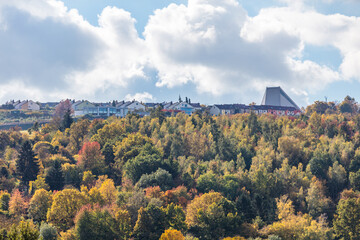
[67,7,147,96]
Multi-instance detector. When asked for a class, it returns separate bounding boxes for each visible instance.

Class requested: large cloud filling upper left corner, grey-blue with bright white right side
[0,0,147,101]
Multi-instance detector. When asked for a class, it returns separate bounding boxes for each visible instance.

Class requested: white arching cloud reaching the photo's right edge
[242,7,360,82]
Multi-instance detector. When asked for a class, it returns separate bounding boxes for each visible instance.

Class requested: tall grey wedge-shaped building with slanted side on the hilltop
[261,87,300,110]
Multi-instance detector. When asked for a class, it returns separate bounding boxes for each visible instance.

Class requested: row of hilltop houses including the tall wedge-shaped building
[6,87,301,117]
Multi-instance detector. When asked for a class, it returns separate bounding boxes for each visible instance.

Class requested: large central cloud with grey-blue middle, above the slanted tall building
[144,0,339,99]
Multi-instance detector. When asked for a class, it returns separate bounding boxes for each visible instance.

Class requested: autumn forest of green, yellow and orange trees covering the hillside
[0,97,360,240]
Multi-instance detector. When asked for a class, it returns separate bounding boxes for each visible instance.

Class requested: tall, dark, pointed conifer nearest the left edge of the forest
[16,140,39,186]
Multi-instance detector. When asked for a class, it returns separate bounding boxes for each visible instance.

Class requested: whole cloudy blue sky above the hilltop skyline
[0,0,360,107]
